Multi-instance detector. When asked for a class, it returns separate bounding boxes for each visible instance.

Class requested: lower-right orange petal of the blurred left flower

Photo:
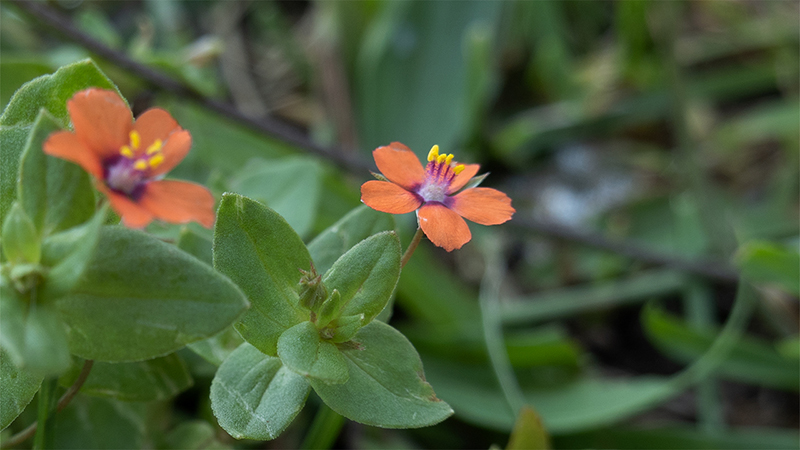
[139,180,214,228]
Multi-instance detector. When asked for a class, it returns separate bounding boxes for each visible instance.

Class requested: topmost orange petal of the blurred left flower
[67,88,133,160]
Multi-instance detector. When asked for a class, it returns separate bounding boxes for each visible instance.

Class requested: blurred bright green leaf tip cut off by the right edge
[736,241,800,295]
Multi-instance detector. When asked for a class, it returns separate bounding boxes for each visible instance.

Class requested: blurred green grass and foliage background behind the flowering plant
[0,0,800,449]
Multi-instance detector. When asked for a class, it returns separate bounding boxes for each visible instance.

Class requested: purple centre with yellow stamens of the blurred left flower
[105,130,164,196]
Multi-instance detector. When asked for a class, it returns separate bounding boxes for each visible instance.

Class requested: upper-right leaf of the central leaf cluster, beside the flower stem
[322,231,401,323]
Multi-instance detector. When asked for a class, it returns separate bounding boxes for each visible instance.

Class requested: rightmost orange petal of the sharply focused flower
[450,188,516,225]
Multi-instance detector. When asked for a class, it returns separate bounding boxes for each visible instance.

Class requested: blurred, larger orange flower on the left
[44,89,214,228]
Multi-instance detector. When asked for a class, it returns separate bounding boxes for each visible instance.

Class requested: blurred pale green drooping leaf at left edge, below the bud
[0,283,71,375]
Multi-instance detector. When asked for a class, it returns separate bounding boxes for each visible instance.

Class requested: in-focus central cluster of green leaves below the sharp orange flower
[211,194,452,439]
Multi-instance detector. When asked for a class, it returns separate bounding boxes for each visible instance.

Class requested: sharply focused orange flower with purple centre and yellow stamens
[361,142,515,252]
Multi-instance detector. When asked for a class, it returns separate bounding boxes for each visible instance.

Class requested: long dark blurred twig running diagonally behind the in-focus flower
[11,0,739,283]
